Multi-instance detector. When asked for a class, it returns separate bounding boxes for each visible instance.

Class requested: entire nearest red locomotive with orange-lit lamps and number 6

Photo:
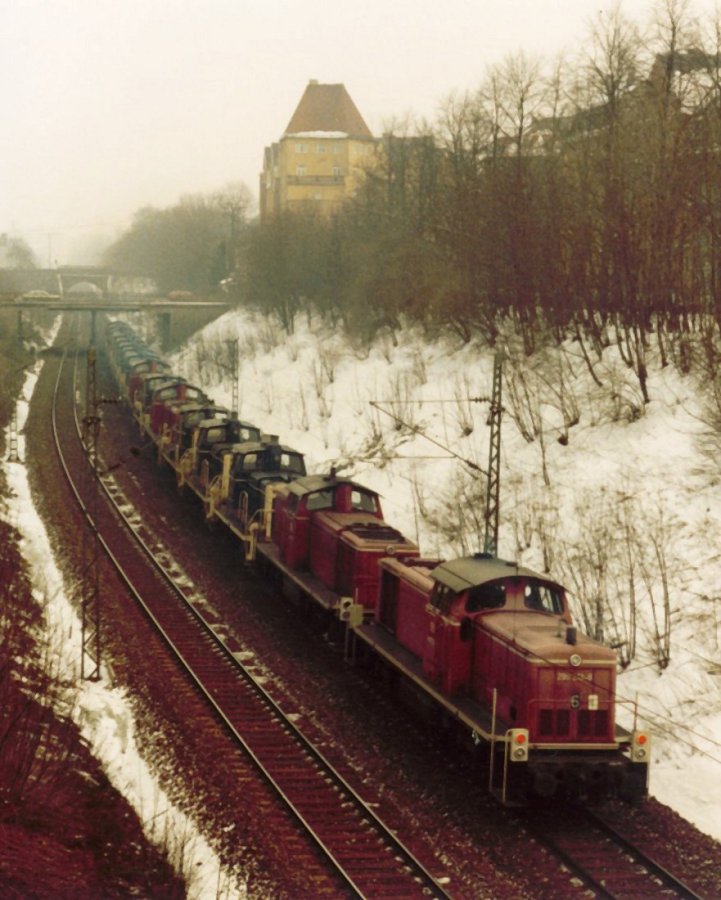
[366,554,649,802]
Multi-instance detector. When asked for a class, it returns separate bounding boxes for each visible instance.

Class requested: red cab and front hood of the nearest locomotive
[423,555,616,732]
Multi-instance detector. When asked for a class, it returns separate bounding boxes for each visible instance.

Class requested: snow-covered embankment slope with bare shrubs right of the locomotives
[167,311,721,839]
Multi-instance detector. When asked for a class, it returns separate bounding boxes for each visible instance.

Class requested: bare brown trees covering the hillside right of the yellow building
[239,3,721,393]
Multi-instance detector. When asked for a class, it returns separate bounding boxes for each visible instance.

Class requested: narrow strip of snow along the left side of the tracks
[3,340,245,900]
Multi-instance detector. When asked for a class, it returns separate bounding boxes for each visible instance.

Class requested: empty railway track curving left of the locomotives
[53,326,449,898]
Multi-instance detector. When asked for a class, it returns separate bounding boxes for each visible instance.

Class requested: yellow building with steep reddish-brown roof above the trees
[260,80,376,220]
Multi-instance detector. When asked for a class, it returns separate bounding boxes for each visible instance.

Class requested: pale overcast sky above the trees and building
[0,0,714,264]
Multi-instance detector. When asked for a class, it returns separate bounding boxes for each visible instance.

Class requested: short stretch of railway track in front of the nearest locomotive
[524,807,700,900]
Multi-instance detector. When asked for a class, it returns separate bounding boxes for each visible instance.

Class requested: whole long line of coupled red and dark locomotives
[106,321,651,805]
